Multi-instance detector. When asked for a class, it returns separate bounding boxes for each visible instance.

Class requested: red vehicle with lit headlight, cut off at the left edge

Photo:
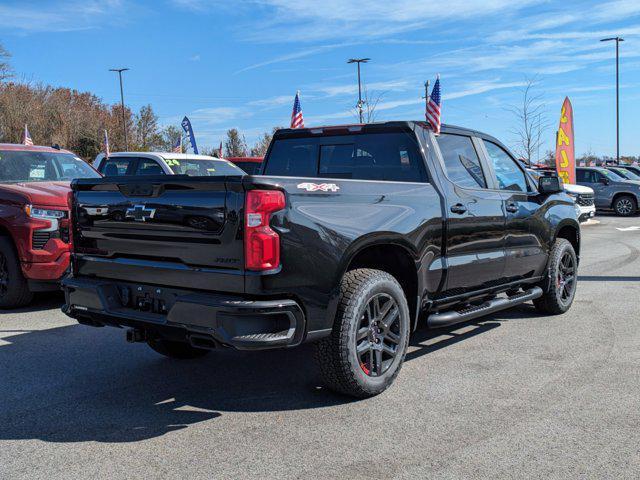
[0,143,100,308]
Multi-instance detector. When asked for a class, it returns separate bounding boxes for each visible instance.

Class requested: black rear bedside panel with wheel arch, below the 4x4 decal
[245,177,443,331]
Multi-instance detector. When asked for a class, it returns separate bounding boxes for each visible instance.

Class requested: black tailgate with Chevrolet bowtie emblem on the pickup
[72,175,244,292]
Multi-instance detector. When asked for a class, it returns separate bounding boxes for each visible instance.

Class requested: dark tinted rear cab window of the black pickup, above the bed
[264,132,427,182]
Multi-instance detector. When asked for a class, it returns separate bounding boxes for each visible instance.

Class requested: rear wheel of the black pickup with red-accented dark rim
[316,268,410,398]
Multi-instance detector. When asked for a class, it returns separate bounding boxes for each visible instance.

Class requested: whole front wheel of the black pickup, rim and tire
[533,238,578,315]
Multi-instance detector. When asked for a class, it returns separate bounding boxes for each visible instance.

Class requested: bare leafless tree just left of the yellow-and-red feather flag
[507,78,549,163]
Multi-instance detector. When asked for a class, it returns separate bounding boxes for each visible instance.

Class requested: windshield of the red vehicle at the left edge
[0,150,100,183]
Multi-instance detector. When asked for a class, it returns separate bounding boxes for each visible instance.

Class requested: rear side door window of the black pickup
[438,134,487,188]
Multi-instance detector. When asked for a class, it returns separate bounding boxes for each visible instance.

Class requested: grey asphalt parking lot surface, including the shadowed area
[0,215,640,479]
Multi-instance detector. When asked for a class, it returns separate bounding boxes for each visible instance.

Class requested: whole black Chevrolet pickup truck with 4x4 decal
[63,121,580,397]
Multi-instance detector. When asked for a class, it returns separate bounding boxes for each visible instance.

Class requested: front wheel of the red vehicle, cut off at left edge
[0,237,33,308]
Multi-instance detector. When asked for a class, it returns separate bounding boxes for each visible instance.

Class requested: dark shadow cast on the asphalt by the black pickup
[0,310,512,442]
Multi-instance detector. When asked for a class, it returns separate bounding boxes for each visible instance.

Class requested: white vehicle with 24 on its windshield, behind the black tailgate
[93,152,241,177]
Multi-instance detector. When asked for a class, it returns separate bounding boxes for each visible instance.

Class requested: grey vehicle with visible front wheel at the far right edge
[576,167,640,217]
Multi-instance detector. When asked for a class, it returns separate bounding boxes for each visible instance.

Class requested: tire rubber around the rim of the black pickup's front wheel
[533,238,578,315]
